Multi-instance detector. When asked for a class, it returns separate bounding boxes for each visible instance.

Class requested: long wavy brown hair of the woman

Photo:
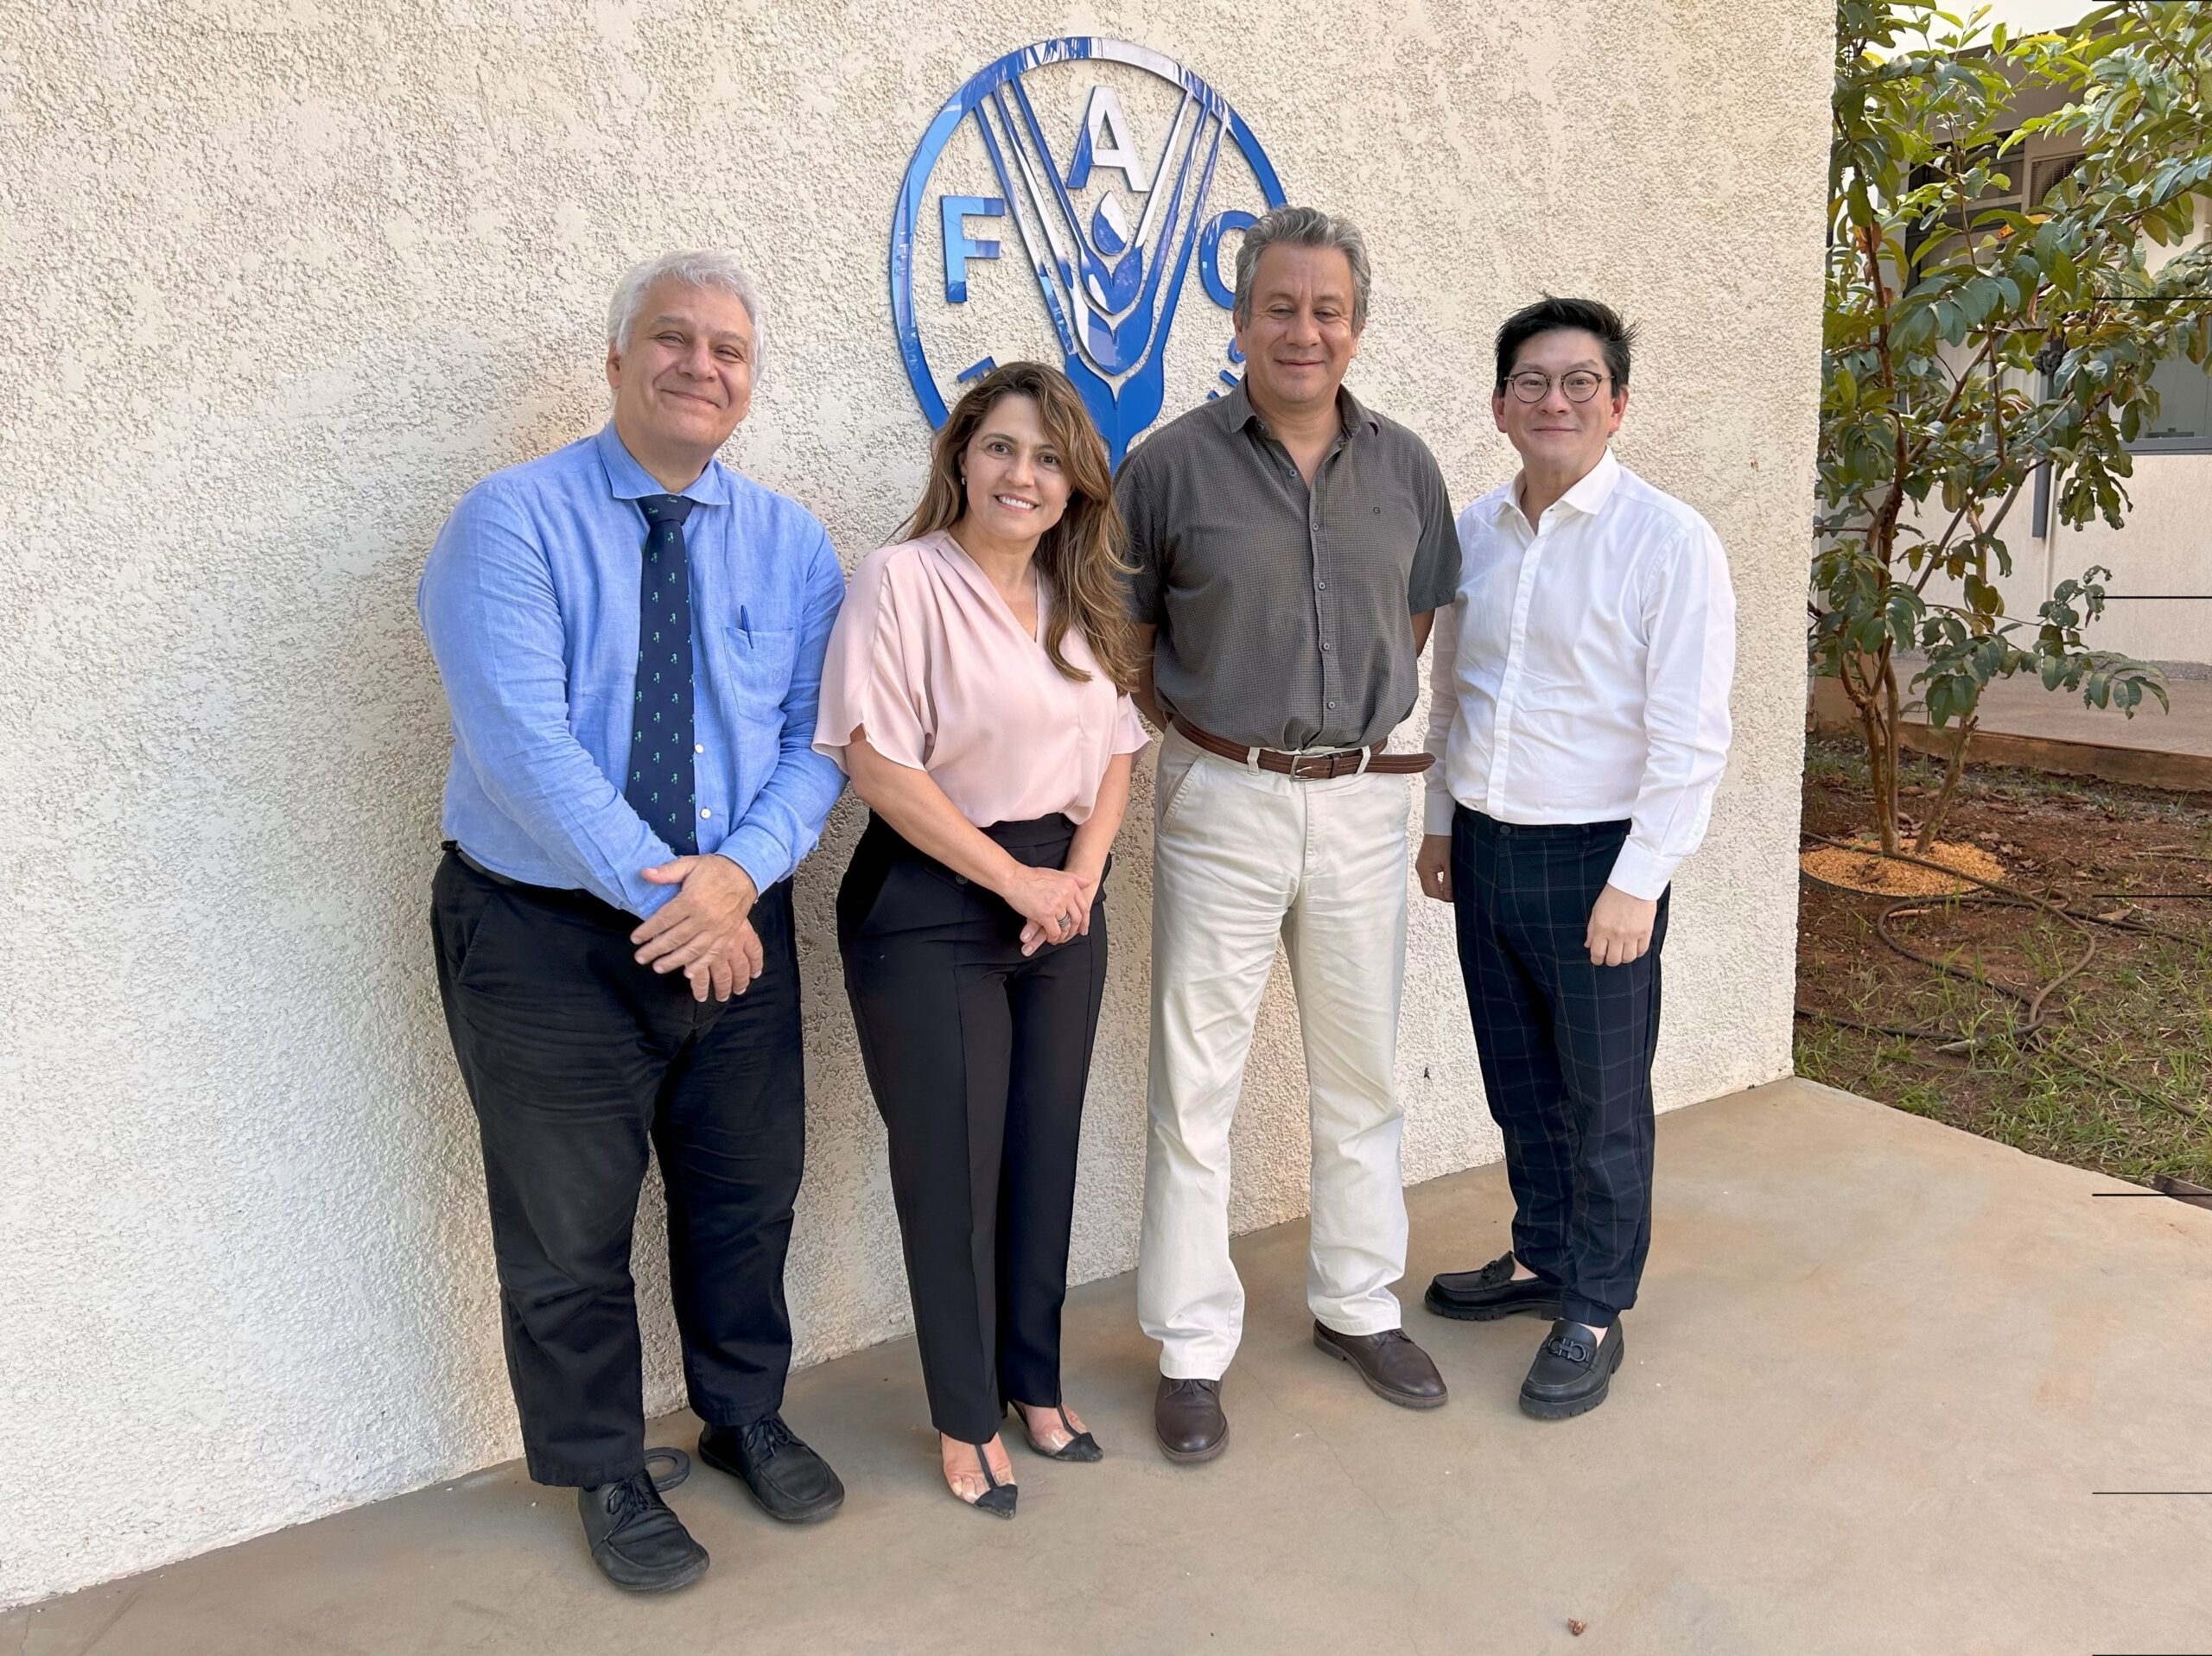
[898,363,1137,695]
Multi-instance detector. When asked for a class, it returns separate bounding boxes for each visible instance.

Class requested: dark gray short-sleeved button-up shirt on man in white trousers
[1115,384,1460,750]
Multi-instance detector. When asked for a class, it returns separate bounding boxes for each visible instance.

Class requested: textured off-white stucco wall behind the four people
[0,0,1829,1603]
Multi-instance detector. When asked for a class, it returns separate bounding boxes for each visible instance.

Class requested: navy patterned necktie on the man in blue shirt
[621,495,699,855]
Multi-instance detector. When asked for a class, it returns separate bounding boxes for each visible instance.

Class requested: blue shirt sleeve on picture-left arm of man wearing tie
[416,485,675,916]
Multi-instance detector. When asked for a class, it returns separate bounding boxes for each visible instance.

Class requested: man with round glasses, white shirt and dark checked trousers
[1415,299,1737,1419]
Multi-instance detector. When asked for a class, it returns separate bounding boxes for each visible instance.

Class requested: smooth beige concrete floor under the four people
[17,1082,2212,1656]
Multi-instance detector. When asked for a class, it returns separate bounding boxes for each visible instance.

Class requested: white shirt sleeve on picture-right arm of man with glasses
[1608,519,1737,900]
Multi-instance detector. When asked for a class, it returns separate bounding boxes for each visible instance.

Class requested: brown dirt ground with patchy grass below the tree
[1796,739,2212,1185]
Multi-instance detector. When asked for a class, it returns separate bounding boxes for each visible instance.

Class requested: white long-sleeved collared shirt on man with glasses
[1425,449,1737,898]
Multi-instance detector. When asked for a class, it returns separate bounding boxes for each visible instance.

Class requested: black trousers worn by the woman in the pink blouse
[838,815,1106,1443]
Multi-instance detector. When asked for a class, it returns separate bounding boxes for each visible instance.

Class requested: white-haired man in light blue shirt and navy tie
[418,254,845,1589]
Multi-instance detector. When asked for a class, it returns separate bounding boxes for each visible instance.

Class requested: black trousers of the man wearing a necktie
[431,849,805,1486]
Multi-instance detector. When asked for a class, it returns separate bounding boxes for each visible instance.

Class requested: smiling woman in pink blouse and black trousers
[814,363,1146,1519]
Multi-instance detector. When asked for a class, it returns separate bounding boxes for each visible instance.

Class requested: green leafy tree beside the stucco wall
[1809,0,2212,851]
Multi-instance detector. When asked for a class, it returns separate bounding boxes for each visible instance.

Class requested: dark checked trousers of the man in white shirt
[1451,805,1668,1329]
